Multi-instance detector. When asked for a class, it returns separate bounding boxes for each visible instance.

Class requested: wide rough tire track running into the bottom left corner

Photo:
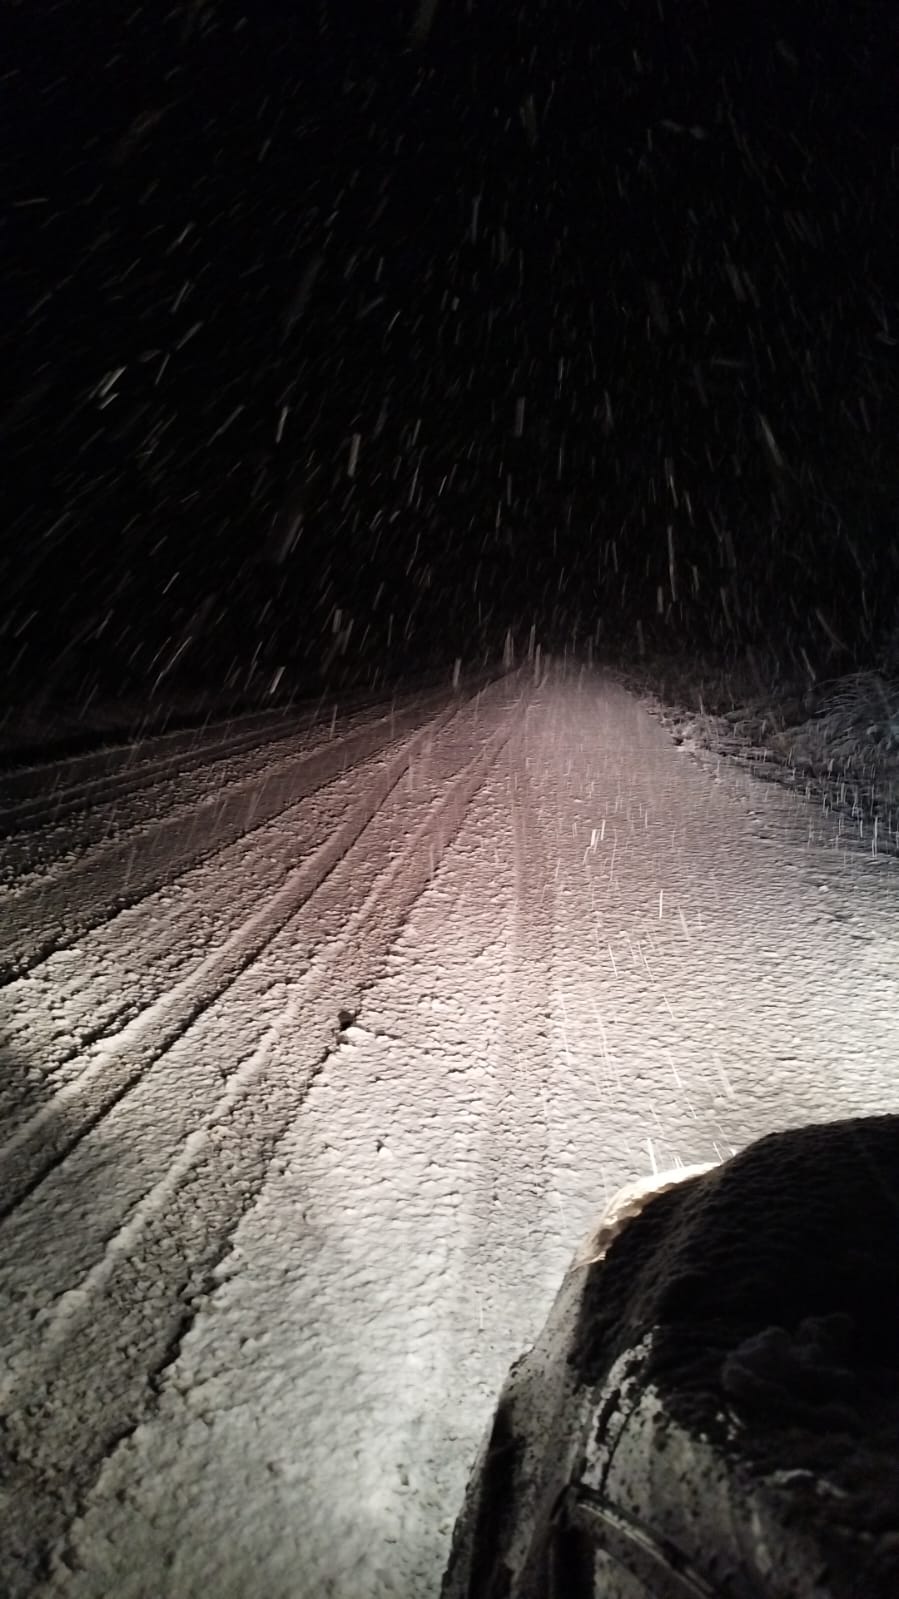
[0,677,520,1599]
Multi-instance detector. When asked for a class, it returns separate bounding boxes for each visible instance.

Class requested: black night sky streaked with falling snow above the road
[0,0,899,699]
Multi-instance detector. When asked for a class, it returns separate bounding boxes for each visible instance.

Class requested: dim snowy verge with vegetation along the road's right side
[608,660,899,857]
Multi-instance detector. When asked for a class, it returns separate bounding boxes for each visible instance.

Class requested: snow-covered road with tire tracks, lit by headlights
[0,673,899,1599]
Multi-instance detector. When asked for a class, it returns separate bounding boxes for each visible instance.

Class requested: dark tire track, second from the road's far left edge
[0,696,454,982]
